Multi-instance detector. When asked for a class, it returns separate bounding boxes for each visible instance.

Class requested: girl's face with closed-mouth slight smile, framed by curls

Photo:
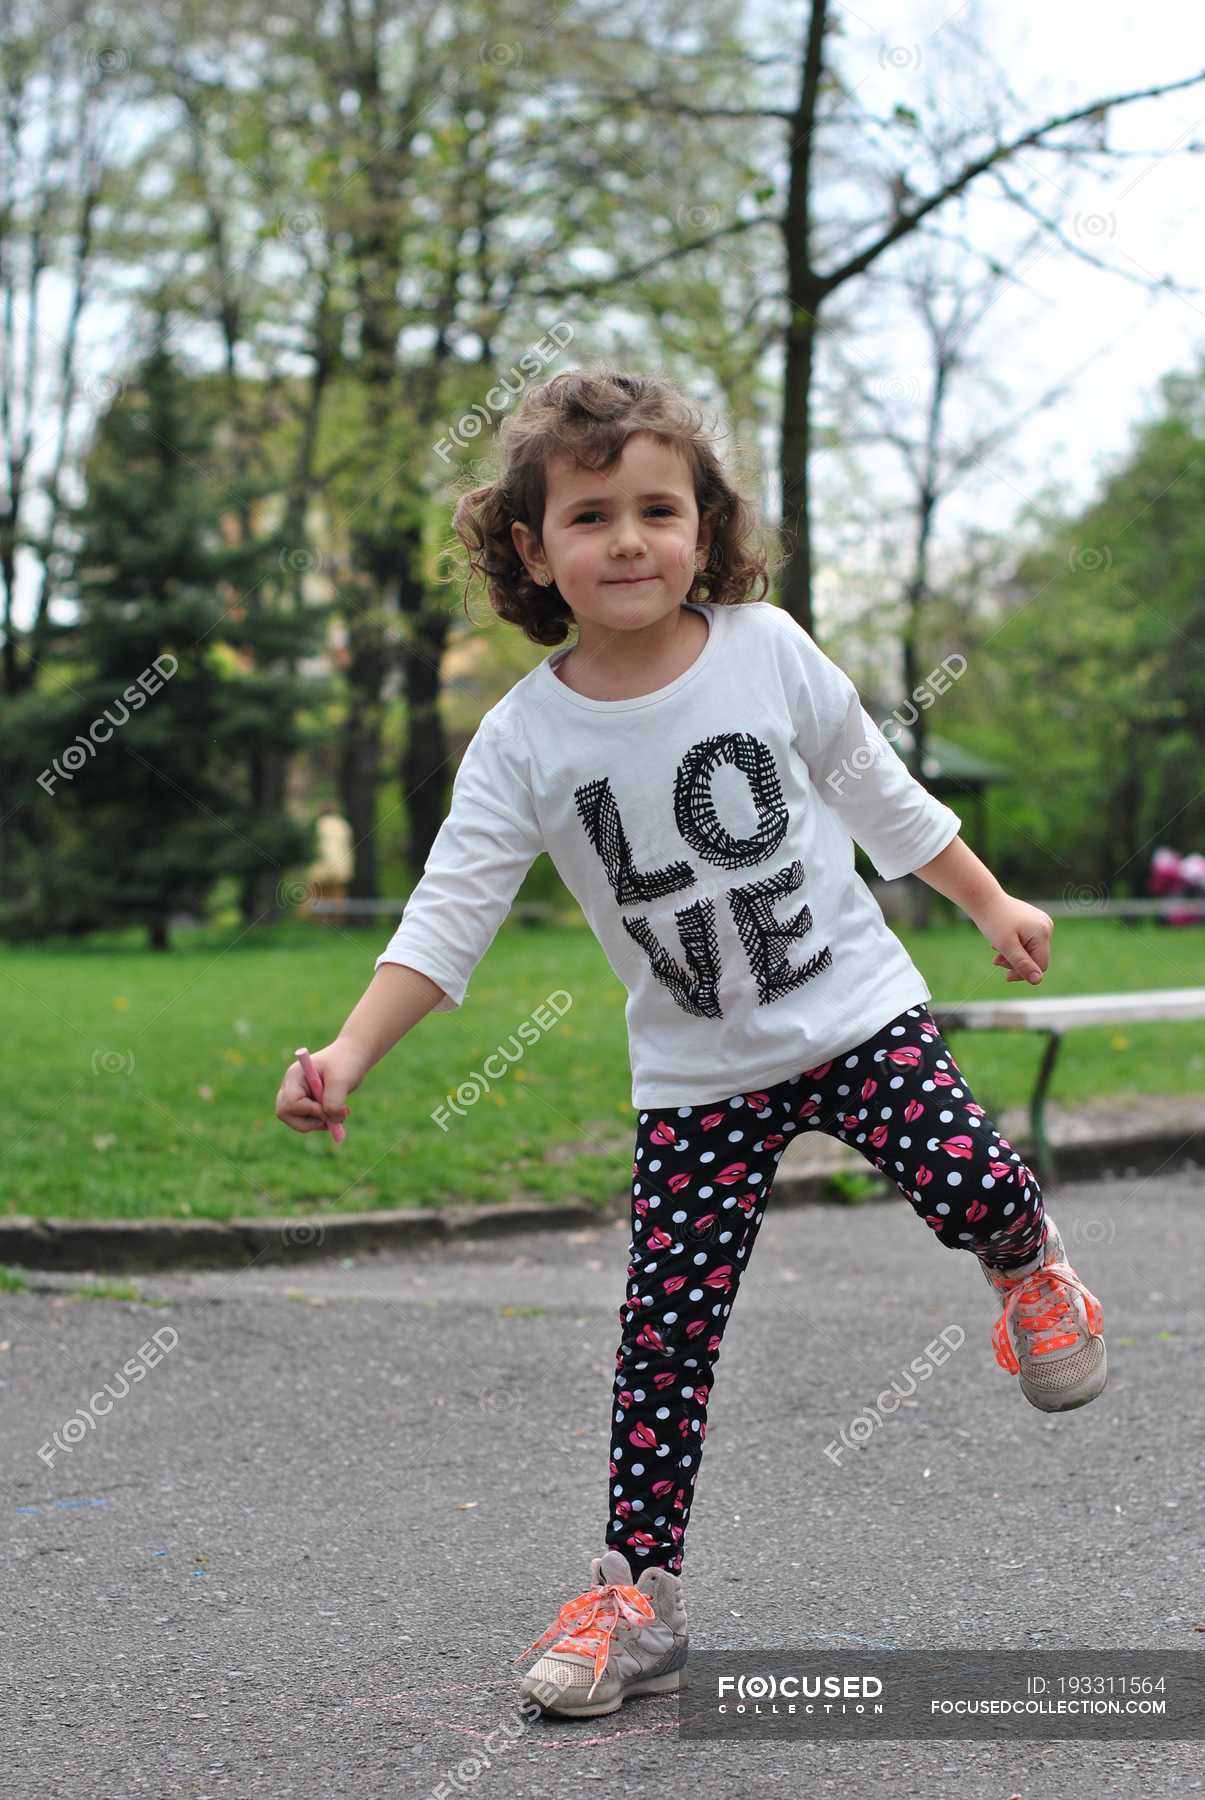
[512,432,710,630]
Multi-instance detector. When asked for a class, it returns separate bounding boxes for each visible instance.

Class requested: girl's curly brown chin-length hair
[452,364,769,644]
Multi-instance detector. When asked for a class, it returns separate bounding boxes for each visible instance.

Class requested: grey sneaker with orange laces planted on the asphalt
[513,1550,690,1719]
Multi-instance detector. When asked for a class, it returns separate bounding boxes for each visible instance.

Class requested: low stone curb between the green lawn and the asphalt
[0,1127,1205,1273]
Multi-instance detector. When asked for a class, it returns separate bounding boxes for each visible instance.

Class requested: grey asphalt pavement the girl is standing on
[0,1170,1205,1800]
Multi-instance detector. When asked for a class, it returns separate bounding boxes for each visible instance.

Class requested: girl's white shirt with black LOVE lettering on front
[376,601,962,1107]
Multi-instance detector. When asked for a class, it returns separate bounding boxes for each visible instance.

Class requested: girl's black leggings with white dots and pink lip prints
[607,1006,1046,1577]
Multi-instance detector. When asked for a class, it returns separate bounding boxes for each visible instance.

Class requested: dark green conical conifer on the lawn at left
[0,311,321,950]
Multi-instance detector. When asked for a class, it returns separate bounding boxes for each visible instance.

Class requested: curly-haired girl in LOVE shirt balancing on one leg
[277,367,1106,1717]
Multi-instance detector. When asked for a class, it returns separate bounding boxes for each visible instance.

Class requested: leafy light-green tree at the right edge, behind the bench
[944,358,1205,911]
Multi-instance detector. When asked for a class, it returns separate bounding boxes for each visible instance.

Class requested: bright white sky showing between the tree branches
[9,0,1205,623]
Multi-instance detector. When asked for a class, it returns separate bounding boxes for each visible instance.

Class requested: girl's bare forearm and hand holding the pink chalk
[276,963,445,1130]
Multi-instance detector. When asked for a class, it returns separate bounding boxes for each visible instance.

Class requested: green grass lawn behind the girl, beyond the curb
[0,920,1205,1219]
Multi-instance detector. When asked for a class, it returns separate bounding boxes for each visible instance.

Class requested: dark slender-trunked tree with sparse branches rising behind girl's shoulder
[530,0,1205,632]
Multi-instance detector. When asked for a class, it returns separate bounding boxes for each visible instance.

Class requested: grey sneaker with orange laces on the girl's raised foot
[980,1213,1108,1413]
